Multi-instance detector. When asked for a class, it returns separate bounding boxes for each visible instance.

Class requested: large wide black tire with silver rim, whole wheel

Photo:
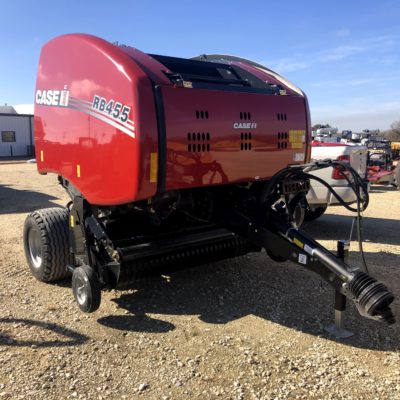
[23,207,69,282]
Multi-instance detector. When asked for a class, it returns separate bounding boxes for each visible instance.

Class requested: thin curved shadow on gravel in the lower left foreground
[0,318,89,348]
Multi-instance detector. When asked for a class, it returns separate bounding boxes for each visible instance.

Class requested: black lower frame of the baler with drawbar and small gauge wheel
[54,161,394,324]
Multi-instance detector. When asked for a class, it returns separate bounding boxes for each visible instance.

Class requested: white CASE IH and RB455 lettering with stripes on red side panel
[35,85,135,138]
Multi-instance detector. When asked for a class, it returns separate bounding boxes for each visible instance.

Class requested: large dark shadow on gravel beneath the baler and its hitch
[98,242,400,351]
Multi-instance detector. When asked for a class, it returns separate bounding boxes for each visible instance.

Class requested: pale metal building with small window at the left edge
[0,105,35,157]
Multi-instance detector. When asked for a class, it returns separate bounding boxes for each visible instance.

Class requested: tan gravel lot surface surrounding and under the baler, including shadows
[0,164,400,400]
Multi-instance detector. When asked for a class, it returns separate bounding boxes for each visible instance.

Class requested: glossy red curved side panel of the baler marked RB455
[35,35,158,205]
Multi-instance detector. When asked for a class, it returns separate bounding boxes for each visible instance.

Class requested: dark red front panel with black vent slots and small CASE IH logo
[162,87,308,190]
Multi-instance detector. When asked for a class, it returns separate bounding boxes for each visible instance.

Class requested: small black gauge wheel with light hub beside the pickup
[72,265,101,313]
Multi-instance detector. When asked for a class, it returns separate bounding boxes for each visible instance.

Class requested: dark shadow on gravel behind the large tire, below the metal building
[0,185,59,214]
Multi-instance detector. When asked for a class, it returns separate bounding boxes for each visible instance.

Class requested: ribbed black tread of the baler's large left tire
[27,207,69,282]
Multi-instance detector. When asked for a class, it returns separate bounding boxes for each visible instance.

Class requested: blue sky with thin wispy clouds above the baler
[0,0,400,131]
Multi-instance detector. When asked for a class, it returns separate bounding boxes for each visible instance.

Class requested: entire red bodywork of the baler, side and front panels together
[35,35,311,205]
